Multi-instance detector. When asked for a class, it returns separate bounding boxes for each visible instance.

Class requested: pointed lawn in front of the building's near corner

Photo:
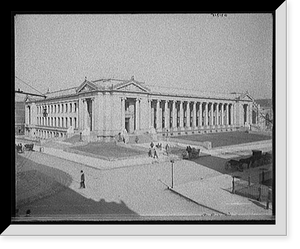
[72,142,145,158]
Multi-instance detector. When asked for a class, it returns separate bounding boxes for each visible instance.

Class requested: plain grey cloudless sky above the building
[15,13,273,99]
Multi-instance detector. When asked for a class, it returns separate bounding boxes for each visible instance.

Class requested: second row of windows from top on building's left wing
[37,117,77,129]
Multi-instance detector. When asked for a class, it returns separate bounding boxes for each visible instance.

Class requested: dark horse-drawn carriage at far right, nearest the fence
[225,150,272,171]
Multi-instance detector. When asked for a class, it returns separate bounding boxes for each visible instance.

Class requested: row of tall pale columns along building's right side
[148,99,236,131]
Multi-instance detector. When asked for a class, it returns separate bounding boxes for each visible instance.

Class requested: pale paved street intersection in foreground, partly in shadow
[16,152,216,218]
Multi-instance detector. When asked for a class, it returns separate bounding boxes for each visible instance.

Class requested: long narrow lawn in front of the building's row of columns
[174,131,272,147]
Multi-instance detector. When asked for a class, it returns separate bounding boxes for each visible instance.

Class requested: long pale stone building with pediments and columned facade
[25,77,258,141]
